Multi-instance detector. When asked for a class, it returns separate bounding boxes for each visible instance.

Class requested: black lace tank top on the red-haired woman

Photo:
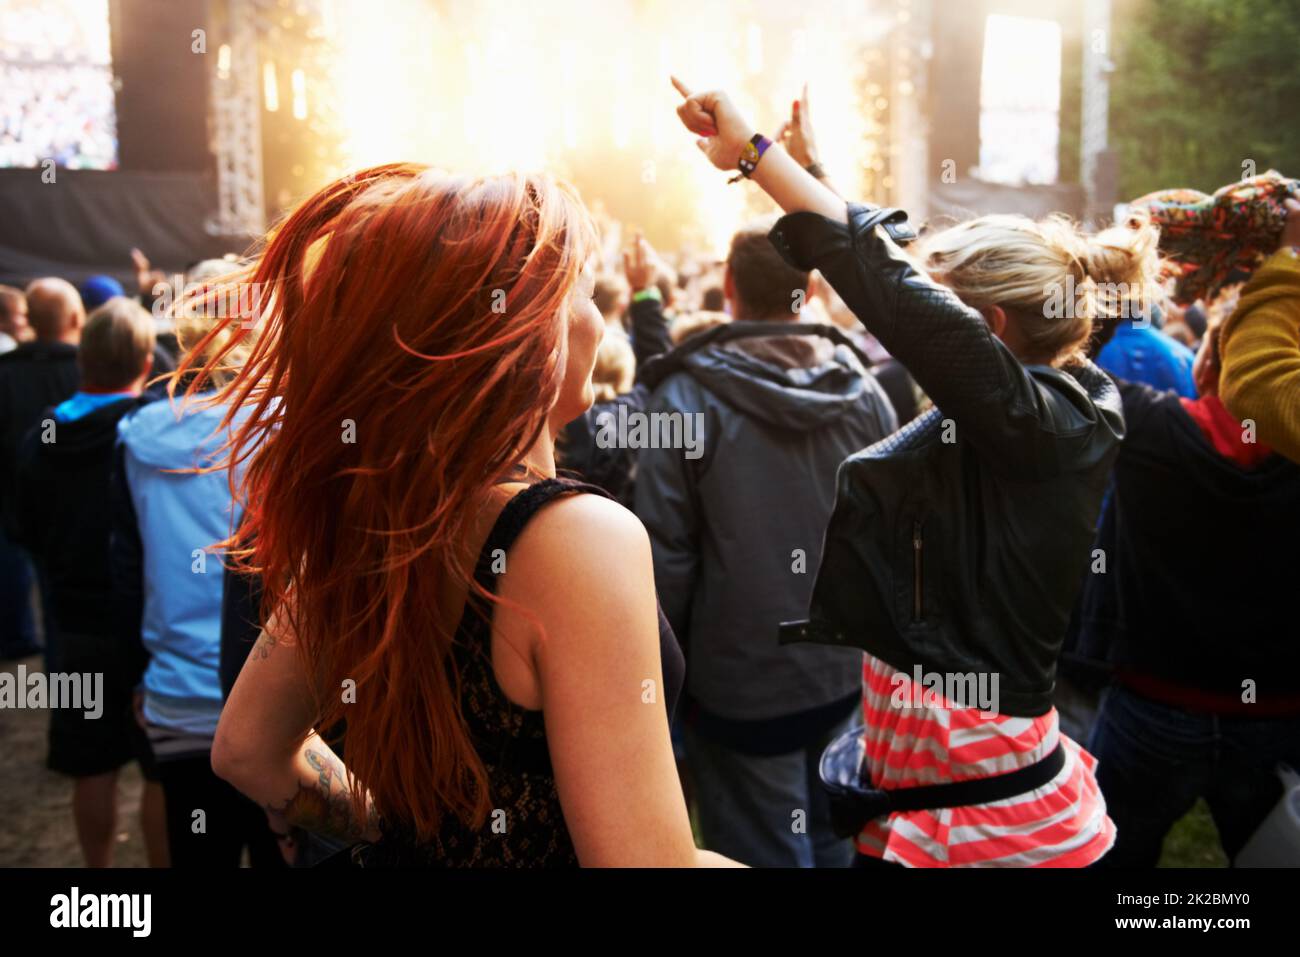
[354,479,686,867]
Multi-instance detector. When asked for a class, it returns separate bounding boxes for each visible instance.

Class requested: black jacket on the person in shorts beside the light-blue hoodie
[16,398,138,647]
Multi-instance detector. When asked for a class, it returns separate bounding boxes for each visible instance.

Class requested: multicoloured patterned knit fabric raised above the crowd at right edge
[1128,169,1300,306]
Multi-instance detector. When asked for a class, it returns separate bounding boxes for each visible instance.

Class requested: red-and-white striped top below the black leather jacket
[857,654,1115,867]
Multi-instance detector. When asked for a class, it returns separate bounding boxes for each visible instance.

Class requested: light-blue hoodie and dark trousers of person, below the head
[113,395,282,867]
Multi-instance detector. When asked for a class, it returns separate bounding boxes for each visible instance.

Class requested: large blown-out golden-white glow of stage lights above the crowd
[315,0,885,252]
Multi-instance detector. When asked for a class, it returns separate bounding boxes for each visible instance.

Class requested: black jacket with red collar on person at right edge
[1079,382,1300,714]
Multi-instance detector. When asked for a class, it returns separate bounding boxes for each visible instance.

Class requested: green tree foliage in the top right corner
[1110,0,1300,199]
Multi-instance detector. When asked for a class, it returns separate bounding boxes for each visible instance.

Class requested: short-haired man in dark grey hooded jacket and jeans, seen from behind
[636,222,897,867]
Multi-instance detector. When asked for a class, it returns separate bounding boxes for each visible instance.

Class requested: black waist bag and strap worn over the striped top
[819,727,1065,837]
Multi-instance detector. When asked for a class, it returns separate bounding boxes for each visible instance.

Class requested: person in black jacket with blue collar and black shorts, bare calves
[13,298,165,867]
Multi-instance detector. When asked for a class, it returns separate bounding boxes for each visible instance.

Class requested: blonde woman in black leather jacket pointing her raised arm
[673,81,1156,867]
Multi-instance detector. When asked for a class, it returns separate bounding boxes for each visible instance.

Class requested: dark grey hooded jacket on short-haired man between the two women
[636,321,897,720]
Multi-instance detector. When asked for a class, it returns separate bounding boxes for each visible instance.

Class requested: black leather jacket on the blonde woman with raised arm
[770,204,1125,716]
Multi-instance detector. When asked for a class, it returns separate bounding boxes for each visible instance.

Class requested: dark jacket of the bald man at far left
[0,342,81,534]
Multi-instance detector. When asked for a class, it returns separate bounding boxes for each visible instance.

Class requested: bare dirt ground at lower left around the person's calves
[0,655,146,867]
